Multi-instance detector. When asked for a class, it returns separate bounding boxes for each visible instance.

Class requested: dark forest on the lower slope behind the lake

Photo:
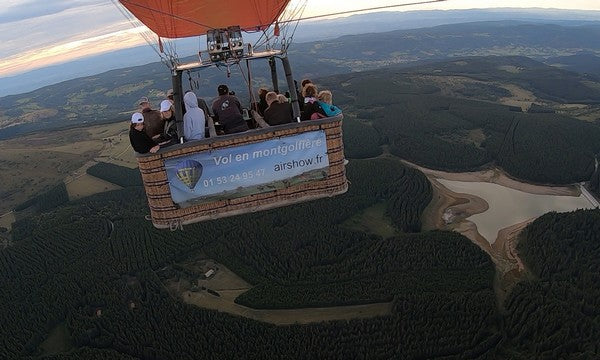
[321,58,600,184]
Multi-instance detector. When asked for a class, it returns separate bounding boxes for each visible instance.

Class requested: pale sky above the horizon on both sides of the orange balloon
[0,0,600,78]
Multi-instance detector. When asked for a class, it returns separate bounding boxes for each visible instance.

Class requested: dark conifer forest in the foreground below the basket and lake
[0,153,600,359]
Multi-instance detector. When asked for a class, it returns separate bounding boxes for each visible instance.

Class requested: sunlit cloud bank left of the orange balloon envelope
[0,0,149,77]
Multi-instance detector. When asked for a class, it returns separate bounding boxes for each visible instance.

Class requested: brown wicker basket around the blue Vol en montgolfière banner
[137,114,348,229]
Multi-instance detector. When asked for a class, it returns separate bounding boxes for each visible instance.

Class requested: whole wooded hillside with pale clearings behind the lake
[321,57,600,184]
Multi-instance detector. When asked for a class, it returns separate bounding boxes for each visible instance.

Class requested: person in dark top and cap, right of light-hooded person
[212,85,249,134]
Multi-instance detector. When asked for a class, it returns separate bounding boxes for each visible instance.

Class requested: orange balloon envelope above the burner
[119,0,290,39]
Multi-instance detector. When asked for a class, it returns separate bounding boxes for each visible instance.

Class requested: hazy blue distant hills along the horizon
[0,8,600,96]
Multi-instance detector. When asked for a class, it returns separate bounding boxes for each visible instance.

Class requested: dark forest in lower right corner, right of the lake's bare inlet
[504,210,600,359]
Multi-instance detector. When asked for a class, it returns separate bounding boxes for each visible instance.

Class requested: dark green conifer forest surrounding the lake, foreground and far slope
[0,54,600,360]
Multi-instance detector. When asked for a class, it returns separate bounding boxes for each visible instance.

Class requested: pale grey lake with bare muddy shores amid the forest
[437,179,594,244]
